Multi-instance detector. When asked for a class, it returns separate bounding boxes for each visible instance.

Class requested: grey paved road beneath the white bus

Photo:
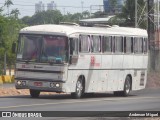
[0,89,160,119]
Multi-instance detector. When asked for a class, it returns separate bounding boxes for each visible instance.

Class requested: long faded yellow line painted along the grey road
[0,97,160,109]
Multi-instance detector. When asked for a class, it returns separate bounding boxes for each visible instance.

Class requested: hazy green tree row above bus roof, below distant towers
[21,10,90,25]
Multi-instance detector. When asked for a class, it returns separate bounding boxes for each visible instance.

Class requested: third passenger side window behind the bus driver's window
[102,36,112,52]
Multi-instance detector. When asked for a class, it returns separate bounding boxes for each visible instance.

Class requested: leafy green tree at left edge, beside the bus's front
[0,3,25,74]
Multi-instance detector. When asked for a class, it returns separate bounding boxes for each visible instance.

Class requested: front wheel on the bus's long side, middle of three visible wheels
[71,79,84,99]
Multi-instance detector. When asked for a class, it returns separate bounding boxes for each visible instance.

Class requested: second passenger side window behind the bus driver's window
[91,35,101,52]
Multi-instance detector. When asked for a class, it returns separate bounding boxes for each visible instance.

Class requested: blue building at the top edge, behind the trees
[103,0,125,14]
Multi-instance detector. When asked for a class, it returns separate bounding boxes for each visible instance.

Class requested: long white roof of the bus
[20,24,148,37]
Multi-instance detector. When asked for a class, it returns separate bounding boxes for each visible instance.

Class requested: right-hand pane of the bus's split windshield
[41,36,67,63]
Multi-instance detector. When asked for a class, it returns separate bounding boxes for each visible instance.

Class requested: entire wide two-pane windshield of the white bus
[17,35,68,63]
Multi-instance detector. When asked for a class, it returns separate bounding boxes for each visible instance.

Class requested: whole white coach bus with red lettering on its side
[15,25,148,98]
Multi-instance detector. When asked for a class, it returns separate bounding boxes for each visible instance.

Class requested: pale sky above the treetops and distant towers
[0,0,103,18]
